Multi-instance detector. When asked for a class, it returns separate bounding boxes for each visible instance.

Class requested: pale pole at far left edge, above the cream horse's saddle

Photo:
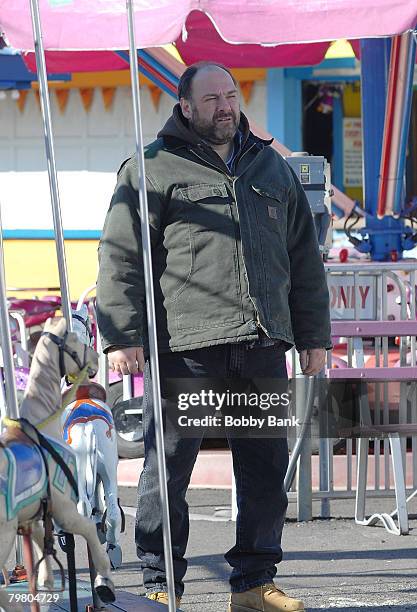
[0,209,19,419]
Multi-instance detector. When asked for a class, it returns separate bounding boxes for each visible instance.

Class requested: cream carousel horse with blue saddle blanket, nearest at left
[0,319,115,612]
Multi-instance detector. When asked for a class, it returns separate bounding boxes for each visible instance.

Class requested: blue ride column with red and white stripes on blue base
[351,32,417,261]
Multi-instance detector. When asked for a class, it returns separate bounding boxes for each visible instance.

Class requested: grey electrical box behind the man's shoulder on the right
[285,152,333,259]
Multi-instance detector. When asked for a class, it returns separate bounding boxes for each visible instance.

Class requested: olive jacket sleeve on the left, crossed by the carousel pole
[97,161,162,351]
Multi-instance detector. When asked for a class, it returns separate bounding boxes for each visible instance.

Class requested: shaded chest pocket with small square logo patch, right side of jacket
[251,185,287,235]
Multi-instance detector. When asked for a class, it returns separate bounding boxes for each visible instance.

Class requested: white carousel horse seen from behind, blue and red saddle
[61,304,124,569]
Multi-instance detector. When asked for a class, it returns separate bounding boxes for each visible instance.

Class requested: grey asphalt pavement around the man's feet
[4,487,417,612]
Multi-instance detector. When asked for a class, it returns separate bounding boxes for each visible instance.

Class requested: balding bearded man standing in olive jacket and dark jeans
[97,63,331,612]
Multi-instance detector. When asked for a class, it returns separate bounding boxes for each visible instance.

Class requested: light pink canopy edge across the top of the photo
[0,0,417,50]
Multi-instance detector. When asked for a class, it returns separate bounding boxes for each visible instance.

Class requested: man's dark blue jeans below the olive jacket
[135,343,288,596]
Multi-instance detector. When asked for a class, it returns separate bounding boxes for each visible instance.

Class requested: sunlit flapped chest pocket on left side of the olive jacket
[179,183,232,233]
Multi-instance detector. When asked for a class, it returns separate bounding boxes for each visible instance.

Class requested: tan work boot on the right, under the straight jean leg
[229,582,304,612]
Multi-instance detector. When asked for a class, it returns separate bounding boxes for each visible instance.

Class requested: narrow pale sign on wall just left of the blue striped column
[343,117,362,187]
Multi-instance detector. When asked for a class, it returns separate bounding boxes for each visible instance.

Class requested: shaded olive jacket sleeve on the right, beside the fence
[287,168,332,351]
